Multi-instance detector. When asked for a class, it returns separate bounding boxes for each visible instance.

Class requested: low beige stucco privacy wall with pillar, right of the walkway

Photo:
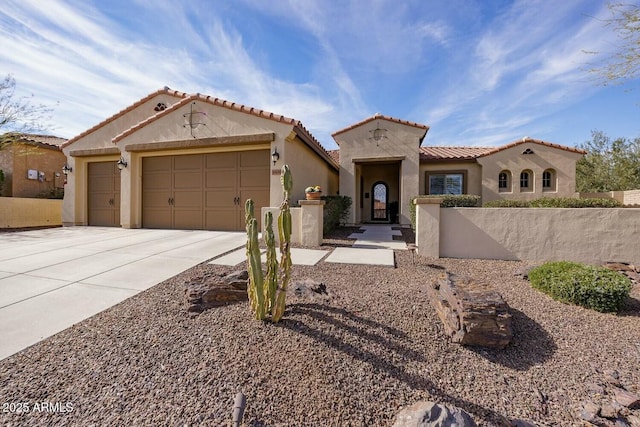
[416,204,640,264]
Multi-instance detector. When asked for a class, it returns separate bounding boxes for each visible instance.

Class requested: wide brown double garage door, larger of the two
[142,150,270,231]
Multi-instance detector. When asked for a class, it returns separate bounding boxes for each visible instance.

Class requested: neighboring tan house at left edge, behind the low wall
[0,133,66,197]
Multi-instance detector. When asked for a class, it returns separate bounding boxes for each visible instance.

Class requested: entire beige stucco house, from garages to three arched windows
[62,87,585,230]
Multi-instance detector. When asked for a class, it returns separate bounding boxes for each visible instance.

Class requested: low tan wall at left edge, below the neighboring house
[0,197,62,228]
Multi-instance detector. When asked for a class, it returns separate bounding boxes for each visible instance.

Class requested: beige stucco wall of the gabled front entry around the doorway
[334,118,425,225]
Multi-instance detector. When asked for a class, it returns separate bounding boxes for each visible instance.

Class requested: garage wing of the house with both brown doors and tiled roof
[62,87,338,230]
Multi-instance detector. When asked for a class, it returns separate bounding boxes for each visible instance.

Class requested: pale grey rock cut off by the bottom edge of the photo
[393,400,476,427]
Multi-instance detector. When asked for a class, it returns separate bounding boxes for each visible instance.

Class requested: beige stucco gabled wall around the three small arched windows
[477,142,582,203]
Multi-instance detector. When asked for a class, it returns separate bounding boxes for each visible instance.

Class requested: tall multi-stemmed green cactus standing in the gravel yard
[245,165,293,323]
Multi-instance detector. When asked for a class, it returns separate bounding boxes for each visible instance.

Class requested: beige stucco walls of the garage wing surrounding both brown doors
[63,95,337,228]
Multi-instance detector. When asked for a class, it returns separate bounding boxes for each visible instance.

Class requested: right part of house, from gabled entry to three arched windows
[331,114,585,224]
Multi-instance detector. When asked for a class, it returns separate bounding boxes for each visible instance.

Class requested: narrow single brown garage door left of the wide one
[87,162,120,227]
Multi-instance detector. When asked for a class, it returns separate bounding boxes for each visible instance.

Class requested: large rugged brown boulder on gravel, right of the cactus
[430,272,513,348]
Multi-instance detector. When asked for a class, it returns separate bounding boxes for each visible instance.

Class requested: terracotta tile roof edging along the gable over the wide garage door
[112,93,338,170]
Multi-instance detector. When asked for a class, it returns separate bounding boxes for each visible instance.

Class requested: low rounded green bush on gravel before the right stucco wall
[529,261,631,313]
